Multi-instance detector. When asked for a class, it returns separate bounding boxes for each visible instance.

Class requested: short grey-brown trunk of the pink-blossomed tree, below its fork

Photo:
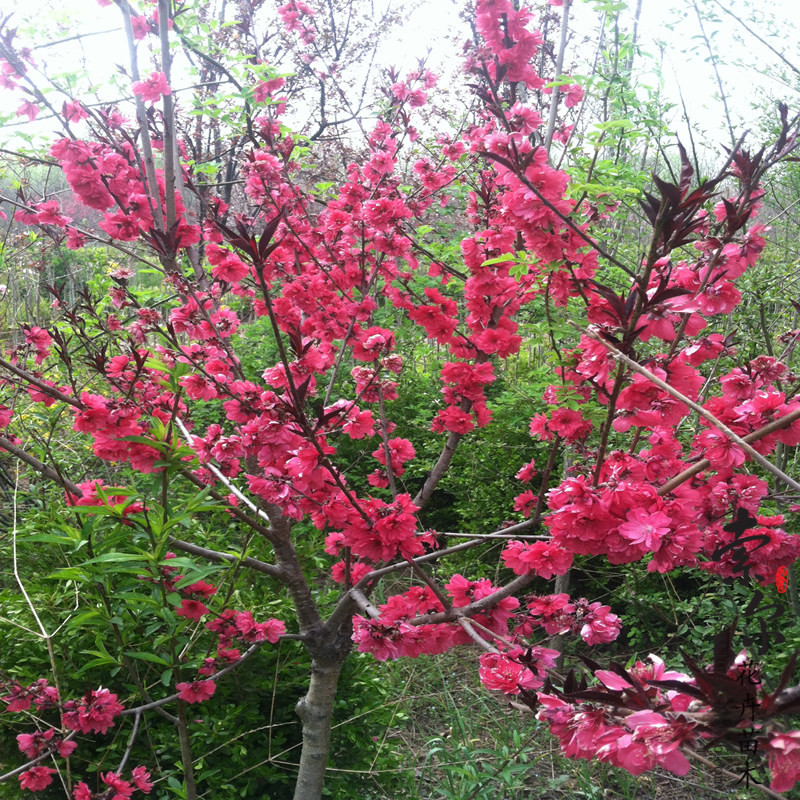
[294,658,342,800]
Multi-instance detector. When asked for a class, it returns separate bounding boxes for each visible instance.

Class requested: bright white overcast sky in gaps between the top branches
[0,0,800,155]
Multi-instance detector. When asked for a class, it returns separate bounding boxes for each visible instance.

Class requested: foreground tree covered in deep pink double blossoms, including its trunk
[0,0,800,800]
